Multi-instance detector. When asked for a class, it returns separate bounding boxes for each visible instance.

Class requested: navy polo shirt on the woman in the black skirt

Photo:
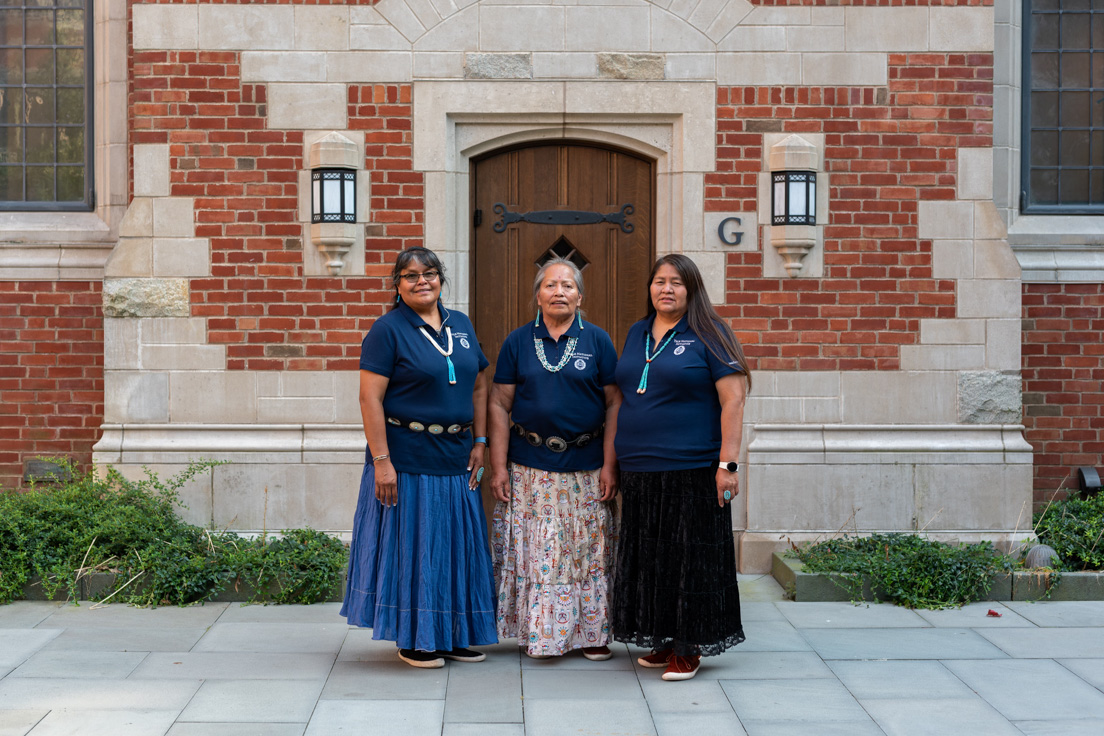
[615,314,743,472]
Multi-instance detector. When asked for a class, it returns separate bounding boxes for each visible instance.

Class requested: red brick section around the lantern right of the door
[705,54,992,371]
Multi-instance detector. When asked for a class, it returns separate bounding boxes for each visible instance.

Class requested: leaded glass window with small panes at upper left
[0,0,93,210]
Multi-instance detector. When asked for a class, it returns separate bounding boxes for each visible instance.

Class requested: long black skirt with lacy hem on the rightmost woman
[609,468,744,657]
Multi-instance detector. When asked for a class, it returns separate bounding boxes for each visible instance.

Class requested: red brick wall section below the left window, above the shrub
[0,281,104,488]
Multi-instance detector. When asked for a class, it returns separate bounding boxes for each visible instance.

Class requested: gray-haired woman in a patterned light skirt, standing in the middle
[487,258,622,660]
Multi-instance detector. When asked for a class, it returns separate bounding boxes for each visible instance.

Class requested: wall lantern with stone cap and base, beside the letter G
[769,135,820,278]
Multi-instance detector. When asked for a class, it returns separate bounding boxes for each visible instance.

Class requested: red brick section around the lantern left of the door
[130,51,424,371]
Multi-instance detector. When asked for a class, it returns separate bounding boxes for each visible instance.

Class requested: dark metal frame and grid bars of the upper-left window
[0,0,96,212]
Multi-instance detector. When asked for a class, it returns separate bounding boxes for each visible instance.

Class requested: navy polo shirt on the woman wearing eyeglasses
[360,302,490,476]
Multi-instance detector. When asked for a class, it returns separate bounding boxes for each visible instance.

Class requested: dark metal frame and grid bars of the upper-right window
[1020,0,1104,215]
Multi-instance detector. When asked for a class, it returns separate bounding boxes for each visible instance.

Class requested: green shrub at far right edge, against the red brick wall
[1034,493,1104,572]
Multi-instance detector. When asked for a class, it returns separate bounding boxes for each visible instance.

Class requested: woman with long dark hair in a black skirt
[611,254,751,680]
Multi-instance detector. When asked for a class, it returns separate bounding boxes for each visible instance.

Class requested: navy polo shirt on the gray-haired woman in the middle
[495,319,617,472]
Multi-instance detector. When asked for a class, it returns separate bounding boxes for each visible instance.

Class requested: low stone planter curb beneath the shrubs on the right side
[771,553,1104,602]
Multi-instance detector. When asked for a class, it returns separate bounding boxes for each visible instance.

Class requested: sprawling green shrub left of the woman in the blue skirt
[0,462,348,606]
